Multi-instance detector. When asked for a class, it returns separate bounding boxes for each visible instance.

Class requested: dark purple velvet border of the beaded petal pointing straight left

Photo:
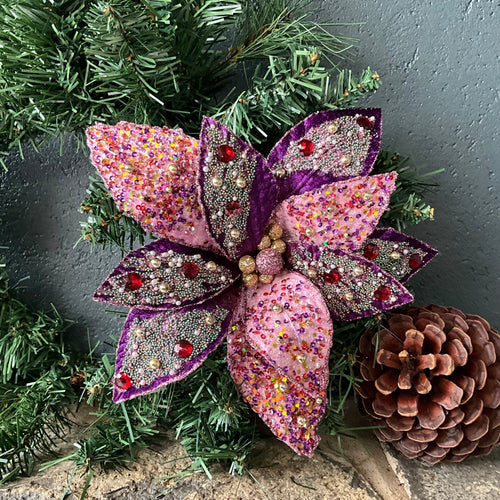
[93,238,241,310]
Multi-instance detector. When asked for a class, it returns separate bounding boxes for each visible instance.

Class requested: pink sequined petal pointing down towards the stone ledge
[228,272,333,456]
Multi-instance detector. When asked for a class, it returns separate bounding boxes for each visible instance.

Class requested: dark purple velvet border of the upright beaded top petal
[199,116,277,260]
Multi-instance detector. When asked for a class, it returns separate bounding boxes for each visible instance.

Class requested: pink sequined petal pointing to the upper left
[87,122,220,252]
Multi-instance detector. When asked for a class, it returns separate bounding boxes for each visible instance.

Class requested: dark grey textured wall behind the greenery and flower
[0,0,500,349]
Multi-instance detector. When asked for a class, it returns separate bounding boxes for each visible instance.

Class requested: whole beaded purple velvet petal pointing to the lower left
[113,287,238,403]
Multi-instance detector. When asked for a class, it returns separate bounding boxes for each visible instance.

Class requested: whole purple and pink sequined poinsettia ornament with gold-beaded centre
[87,109,436,456]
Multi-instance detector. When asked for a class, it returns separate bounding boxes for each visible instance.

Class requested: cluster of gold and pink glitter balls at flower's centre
[238,222,286,287]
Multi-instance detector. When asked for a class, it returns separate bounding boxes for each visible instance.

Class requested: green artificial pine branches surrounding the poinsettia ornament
[0,0,440,492]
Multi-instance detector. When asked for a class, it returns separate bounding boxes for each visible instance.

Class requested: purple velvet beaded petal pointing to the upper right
[268,108,382,201]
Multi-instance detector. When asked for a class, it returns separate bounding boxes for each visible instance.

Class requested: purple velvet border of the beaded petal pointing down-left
[113,287,239,403]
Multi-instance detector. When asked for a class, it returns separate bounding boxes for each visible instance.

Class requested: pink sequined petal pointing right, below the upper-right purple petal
[275,172,397,252]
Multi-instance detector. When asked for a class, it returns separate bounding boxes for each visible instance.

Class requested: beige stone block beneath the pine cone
[383,444,500,500]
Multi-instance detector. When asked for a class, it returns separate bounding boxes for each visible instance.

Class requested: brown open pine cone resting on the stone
[358,305,500,464]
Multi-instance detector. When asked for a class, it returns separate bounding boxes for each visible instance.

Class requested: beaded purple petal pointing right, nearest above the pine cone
[288,244,413,321]
